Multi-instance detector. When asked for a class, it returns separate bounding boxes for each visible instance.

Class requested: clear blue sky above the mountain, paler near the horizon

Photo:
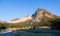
[0,0,60,21]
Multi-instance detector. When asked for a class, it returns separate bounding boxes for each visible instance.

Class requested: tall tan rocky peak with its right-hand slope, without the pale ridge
[33,8,57,22]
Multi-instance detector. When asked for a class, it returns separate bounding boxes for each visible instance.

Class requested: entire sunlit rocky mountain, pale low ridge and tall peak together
[9,8,58,23]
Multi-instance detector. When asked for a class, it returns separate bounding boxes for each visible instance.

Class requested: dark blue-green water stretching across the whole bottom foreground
[0,28,60,36]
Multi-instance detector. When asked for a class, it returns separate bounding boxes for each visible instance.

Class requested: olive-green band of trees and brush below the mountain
[0,18,60,29]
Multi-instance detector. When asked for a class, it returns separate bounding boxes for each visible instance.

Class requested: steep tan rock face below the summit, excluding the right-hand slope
[34,8,44,22]
